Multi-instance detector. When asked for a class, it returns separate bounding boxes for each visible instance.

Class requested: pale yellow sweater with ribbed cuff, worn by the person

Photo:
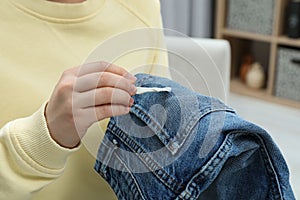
[0,0,168,200]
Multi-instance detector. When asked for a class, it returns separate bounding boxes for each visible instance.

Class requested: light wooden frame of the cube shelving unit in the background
[215,0,300,108]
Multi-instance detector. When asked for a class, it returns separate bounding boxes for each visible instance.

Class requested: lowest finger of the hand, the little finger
[83,104,130,122]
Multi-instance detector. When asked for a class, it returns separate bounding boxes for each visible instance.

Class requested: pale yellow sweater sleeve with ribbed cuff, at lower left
[0,104,79,200]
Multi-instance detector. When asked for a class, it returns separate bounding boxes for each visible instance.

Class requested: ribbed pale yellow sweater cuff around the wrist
[10,103,80,172]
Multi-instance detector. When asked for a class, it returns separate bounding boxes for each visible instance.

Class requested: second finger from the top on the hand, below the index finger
[75,72,136,95]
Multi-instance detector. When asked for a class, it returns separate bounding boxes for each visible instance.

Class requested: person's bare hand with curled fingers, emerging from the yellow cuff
[45,62,136,148]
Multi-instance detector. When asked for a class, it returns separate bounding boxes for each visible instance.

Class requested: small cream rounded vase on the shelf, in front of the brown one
[246,62,265,89]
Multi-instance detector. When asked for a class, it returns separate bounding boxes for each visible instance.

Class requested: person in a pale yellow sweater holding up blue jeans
[0,0,168,200]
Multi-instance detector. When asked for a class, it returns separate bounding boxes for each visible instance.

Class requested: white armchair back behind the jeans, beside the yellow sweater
[166,36,230,103]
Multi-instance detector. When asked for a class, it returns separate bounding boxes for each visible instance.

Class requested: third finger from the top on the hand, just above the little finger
[73,87,133,108]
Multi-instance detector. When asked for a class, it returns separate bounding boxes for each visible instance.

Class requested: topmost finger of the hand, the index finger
[77,61,136,81]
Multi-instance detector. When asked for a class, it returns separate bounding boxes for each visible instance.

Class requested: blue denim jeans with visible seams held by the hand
[94,74,295,200]
